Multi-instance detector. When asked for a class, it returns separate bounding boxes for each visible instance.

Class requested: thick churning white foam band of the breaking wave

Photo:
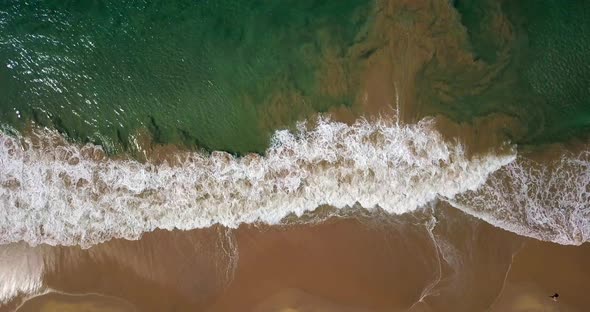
[0,119,515,247]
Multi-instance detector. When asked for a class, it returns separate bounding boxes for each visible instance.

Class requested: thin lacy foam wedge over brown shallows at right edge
[450,151,590,245]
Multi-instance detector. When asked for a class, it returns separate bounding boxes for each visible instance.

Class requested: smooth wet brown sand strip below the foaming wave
[3,205,590,311]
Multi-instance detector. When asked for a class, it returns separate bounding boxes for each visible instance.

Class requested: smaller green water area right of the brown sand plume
[421,0,590,145]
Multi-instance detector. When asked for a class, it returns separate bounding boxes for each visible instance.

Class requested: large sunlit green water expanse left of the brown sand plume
[0,0,370,153]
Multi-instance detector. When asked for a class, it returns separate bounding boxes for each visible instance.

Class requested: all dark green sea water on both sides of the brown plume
[0,0,590,153]
